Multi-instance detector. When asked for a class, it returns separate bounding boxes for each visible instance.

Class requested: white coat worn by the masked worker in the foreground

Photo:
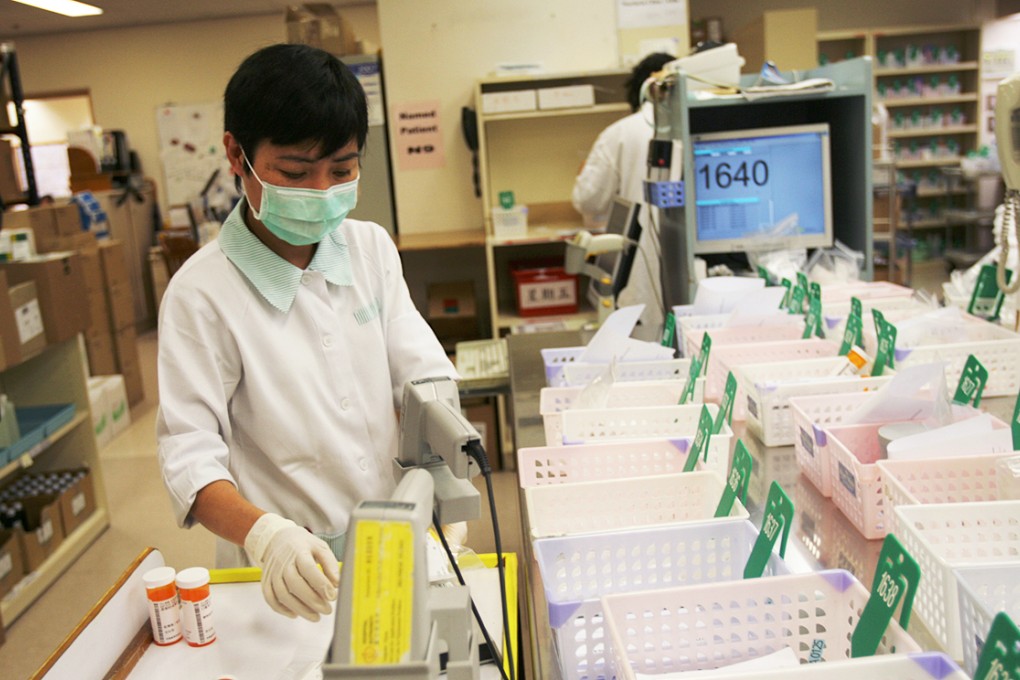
[157,208,457,567]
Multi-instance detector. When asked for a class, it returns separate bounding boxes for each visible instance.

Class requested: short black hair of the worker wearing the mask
[223,44,368,171]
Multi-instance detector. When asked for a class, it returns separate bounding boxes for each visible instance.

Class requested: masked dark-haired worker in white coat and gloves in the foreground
[156,45,458,621]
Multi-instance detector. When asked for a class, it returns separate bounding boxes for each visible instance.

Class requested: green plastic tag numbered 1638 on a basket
[850,533,921,659]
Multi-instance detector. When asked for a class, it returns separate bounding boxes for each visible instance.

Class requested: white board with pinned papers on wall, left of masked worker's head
[156,102,237,214]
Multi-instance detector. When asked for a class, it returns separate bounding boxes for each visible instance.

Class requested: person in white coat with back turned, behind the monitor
[571,52,676,341]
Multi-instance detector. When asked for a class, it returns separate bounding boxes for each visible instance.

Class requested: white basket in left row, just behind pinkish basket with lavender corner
[561,404,733,461]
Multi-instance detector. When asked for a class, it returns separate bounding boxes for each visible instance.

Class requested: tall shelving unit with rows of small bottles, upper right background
[817,24,982,282]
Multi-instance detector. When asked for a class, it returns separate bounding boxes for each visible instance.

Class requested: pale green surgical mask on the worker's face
[245,155,358,246]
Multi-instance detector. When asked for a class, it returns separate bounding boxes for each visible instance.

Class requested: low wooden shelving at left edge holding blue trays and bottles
[0,337,110,625]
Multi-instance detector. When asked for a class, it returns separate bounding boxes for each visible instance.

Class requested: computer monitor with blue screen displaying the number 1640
[686,123,832,255]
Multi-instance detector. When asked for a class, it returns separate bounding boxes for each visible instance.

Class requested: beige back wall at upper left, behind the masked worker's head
[6,5,378,221]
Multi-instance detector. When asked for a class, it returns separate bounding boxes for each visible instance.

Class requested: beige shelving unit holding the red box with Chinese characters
[474,70,630,337]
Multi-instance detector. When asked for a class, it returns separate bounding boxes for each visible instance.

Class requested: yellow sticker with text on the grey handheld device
[351,521,414,666]
